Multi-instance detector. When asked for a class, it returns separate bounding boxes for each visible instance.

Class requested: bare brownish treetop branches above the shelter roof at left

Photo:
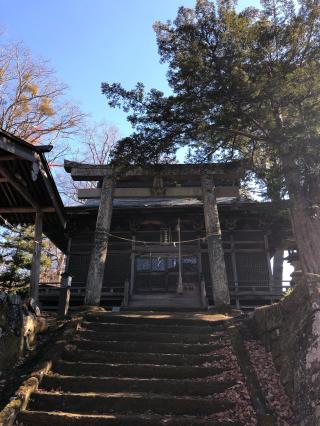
[0,43,84,144]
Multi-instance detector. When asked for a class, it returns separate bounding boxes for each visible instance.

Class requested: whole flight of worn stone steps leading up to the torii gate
[18,312,251,426]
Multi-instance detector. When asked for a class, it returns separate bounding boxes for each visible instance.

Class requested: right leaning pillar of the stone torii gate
[201,175,230,306]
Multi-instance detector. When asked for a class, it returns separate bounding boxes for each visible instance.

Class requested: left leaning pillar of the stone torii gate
[84,177,113,306]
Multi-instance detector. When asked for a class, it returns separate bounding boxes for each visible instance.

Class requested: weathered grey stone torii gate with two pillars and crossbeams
[64,161,244,306]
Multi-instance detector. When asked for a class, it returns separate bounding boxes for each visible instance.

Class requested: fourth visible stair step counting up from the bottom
[53,361,231,379]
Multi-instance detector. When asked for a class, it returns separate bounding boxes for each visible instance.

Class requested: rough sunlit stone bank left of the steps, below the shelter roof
[0,292,47,375]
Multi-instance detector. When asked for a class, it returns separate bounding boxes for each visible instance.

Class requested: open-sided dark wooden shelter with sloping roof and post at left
[0,130,68,301]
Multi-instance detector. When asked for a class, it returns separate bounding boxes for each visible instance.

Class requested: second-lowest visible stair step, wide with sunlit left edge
[29,391,235,416]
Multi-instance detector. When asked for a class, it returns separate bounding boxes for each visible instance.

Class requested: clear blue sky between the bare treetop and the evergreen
[0,0,257,136]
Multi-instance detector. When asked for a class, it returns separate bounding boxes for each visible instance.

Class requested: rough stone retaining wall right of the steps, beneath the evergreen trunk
[250,275,320,426]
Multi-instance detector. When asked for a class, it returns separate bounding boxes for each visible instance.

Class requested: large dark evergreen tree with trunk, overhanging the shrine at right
[102,0,320,274]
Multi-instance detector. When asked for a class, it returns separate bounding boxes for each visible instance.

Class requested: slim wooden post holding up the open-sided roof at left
[30,210,43,303]
